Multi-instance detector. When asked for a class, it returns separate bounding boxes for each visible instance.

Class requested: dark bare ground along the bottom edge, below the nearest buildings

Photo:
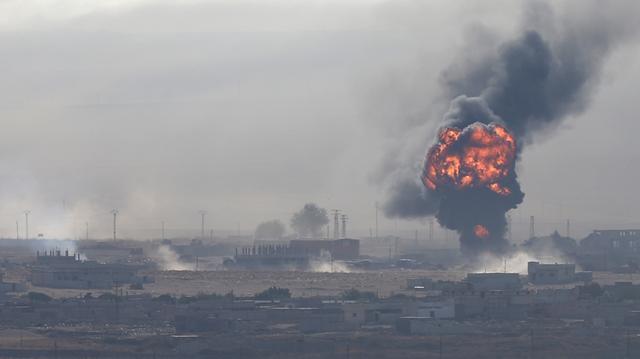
[0,328,640,359]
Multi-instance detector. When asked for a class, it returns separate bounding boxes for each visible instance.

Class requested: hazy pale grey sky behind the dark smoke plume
[0,0,640,242]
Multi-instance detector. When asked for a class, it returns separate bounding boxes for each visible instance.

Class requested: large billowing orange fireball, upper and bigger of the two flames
[422,123,516,196]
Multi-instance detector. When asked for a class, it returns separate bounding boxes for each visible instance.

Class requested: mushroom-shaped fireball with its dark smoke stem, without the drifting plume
[421,122,524,254]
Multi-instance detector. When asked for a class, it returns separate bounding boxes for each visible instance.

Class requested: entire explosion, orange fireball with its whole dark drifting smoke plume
[381,2,637,259]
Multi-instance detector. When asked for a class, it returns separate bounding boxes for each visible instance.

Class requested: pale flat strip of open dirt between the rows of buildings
[20,269,640,298]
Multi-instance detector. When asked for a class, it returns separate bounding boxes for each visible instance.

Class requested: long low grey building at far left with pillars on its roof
[31,250,146,289]
